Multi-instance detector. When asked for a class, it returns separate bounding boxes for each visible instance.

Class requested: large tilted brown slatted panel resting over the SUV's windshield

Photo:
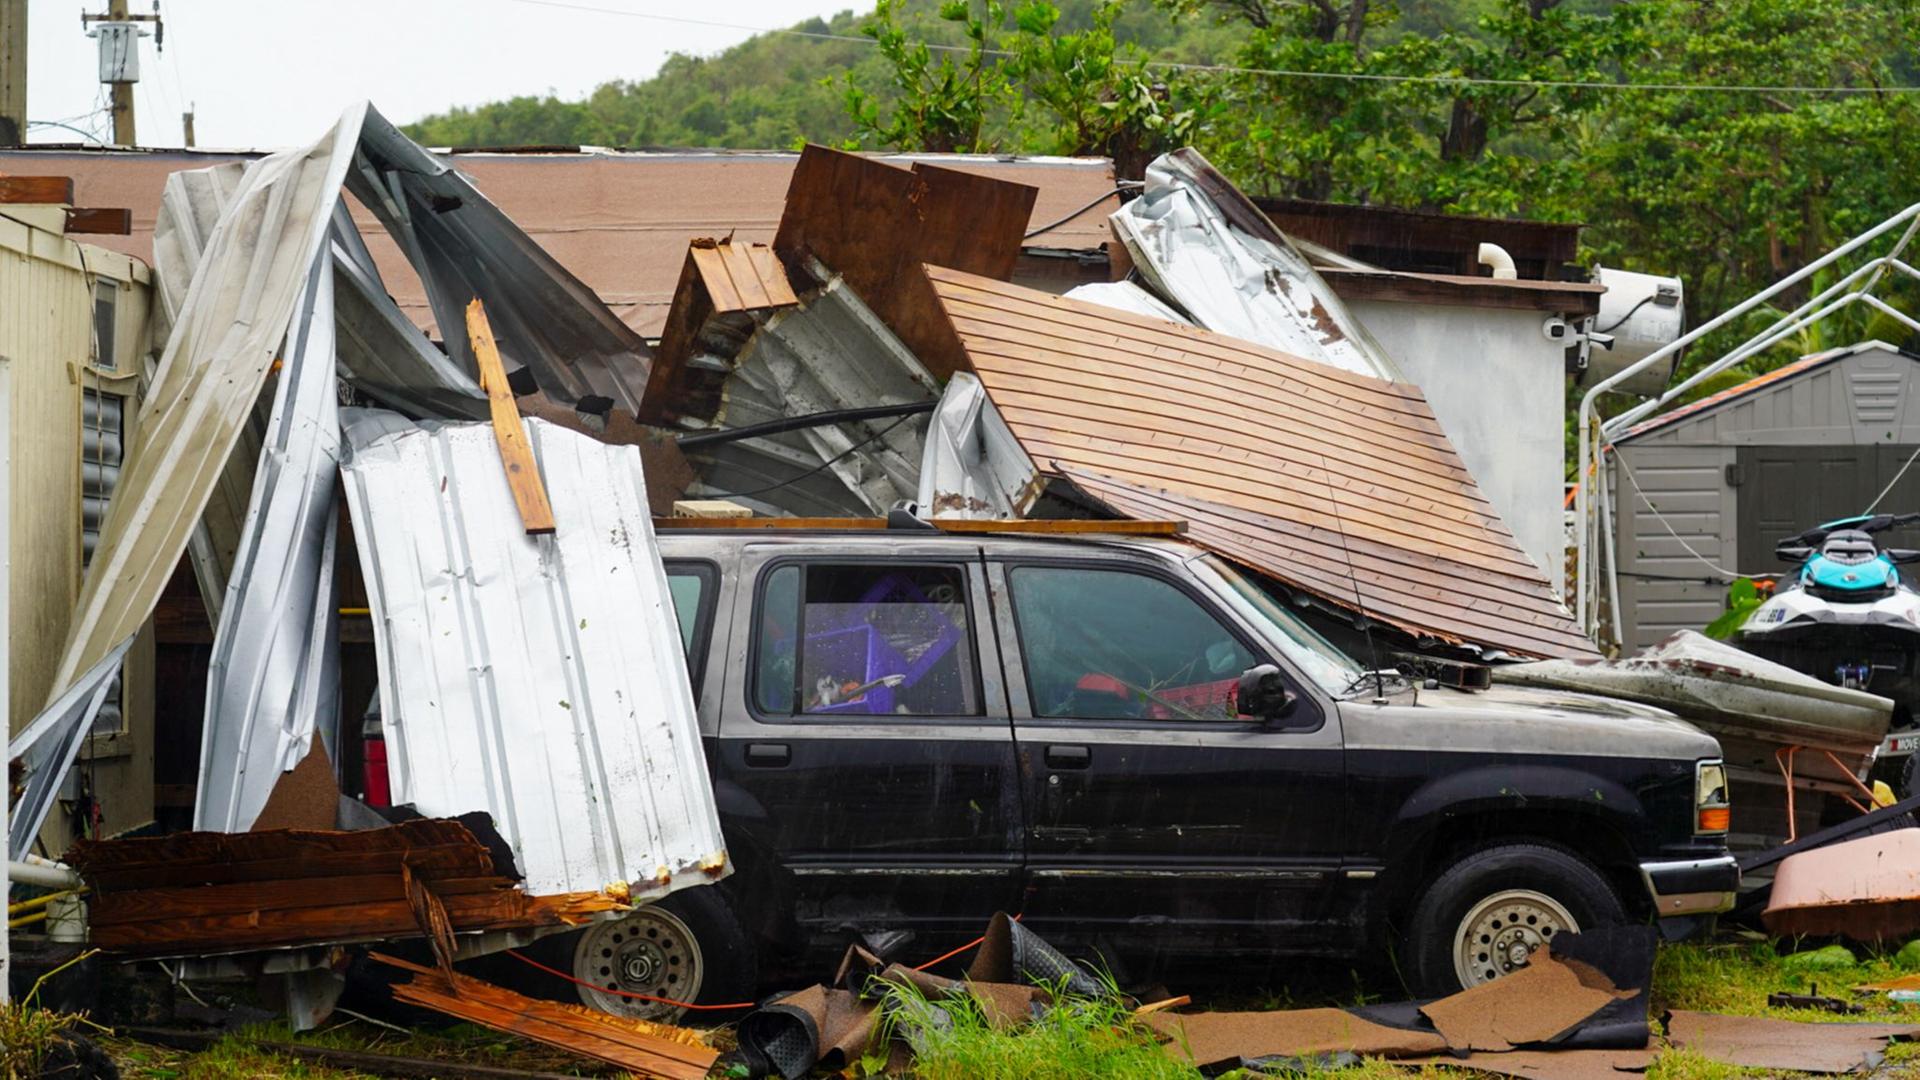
[927,267,1594,655]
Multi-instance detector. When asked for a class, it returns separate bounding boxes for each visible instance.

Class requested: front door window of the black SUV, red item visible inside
[1008,567,1260,721]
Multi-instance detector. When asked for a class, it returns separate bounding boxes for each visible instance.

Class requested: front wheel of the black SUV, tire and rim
[1405,844,1626,997]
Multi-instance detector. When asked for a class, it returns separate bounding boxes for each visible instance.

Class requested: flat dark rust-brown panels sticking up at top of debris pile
[774,146,1039,379]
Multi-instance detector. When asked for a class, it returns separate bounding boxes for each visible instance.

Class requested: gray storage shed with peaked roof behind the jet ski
[1607,342,1920,655]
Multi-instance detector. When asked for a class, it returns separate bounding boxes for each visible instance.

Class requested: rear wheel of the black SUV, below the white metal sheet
[530,886,758,1020]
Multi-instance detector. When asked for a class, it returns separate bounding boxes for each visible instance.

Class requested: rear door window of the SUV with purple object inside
[751,561,981,717]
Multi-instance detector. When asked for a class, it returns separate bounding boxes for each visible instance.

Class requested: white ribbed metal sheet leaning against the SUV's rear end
[344,409,724,896]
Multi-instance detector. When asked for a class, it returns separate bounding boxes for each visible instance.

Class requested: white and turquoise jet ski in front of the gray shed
[1736,513,1920,788]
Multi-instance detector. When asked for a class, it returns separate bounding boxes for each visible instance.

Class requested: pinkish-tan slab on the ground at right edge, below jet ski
[1763,828,1920,942]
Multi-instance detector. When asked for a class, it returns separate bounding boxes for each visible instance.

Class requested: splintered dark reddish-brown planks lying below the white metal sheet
[67,819,622,957]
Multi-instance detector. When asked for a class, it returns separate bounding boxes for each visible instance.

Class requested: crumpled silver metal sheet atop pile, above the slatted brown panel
[1114,146,1404,380]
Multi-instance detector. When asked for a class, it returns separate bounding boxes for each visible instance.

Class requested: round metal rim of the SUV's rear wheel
[574,905,705,1020]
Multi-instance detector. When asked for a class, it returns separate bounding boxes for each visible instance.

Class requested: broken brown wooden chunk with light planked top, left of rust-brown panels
[639,240,801,423]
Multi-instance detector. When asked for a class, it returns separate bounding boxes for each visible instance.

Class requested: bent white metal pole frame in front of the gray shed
[1574,202,1920,632]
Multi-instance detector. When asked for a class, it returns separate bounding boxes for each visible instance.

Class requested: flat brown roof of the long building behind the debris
[0,150,1119,336]
